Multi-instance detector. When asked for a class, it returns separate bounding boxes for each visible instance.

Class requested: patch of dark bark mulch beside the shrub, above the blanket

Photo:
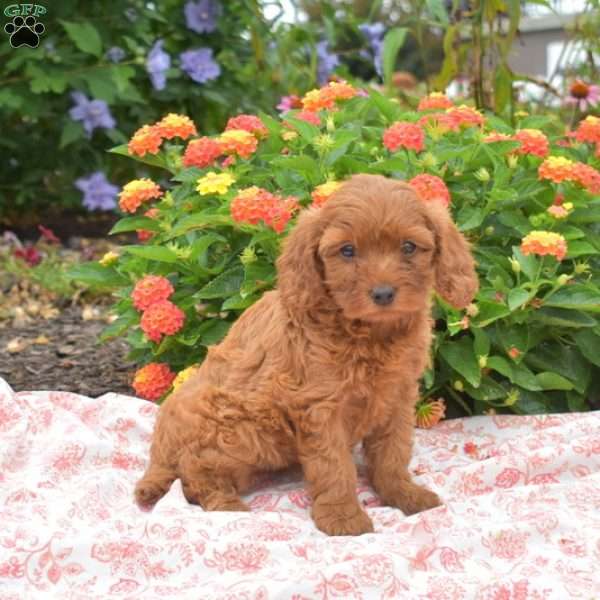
[0,306,135,398]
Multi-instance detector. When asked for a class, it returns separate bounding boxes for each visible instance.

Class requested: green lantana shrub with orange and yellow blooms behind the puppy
[76,83,600,414]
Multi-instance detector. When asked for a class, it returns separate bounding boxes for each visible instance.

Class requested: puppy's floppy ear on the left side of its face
[277,209,326,312]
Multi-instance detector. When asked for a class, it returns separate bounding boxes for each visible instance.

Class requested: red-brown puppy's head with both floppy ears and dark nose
[277,175,478,322]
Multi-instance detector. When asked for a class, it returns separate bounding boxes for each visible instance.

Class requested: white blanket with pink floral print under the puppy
[0,379,600,600]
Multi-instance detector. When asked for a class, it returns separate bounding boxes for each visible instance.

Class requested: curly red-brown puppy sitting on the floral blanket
[135,175,478,535]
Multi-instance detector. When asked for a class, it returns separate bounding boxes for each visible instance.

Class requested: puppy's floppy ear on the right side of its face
[427,202,479,308]
